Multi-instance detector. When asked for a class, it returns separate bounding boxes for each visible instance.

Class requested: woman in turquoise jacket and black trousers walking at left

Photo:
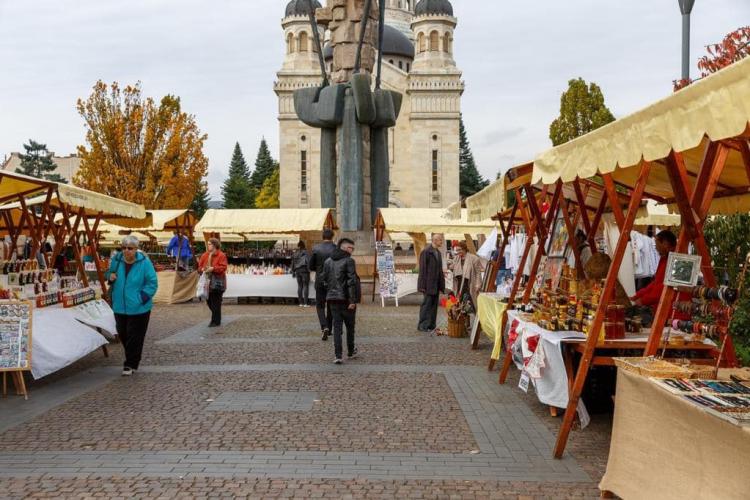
[107,235,158,377]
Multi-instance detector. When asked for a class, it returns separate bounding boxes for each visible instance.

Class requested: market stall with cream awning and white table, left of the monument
[195,209,336,298]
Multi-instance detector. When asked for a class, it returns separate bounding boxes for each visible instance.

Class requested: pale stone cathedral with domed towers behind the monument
[274,0,464,208]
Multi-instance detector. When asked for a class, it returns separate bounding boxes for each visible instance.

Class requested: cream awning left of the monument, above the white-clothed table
[195,208,335,239]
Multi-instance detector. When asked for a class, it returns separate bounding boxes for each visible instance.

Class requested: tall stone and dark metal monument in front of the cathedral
[294,0,402,233]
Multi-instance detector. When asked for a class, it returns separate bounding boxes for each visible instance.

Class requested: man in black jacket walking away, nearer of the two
[323,238,362,365]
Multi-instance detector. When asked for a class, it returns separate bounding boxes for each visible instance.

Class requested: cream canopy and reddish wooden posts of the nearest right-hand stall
[525,54,750,460]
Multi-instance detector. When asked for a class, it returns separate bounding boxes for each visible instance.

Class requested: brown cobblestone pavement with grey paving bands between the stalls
[0,304,611,498]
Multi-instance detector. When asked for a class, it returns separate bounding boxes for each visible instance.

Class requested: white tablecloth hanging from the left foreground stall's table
[31,306,114,379]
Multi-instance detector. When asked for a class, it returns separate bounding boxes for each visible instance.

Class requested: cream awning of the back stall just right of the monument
[376,208,497,234]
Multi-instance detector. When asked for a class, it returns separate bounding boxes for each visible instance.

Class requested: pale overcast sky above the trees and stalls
[0,0,750,199]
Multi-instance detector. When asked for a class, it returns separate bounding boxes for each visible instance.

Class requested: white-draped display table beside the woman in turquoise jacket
[31,301,117,379]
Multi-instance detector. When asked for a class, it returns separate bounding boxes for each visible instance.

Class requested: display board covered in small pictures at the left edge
[0,301,32,372]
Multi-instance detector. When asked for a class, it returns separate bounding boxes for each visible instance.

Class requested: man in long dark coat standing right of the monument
[417,234,445,332]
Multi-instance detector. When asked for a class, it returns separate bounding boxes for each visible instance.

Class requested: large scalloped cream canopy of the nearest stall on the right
[532,58,750,213]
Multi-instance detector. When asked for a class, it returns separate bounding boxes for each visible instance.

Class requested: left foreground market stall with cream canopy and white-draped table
[0,172,145,393]
